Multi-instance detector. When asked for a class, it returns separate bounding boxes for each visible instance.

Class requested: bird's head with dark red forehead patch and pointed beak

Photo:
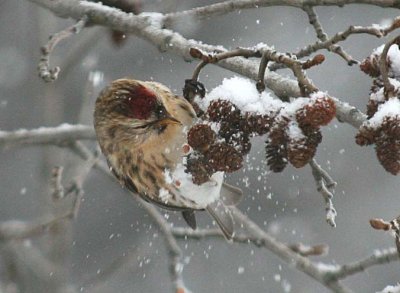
[94,79,181,150]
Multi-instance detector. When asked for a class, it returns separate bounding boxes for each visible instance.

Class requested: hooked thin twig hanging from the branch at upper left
[38,16,88,82]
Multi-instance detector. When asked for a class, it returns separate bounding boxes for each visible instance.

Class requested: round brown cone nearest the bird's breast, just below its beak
[187,124,216,153]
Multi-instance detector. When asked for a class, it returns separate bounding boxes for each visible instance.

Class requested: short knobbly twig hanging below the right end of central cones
[309,159,337,227]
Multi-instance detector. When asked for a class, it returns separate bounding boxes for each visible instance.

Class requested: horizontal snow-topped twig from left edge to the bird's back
[0,124,96,148]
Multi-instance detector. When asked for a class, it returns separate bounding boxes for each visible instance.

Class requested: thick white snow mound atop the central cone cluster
[196,76,284,114]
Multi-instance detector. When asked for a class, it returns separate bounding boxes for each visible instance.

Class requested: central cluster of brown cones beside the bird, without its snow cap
[186,81,336,184]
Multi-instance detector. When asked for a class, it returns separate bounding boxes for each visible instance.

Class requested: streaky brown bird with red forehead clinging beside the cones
[94,78,242,240]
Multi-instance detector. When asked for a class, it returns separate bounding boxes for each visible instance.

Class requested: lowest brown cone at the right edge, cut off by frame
[376,137,400,175]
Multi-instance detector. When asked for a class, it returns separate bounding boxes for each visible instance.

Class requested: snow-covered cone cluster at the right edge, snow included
[356,45,400,175]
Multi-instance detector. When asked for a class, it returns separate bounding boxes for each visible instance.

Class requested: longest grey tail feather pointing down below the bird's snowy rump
[206,200,234,240]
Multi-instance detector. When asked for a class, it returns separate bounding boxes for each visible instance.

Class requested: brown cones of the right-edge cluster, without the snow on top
[356,49,400,175]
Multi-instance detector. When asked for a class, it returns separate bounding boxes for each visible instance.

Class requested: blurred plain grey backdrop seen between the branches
[0,0,400,293]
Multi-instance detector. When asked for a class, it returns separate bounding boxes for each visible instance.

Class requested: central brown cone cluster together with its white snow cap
[186,78,336,184]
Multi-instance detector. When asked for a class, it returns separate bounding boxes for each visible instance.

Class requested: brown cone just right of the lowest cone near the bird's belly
[205,143,243,173]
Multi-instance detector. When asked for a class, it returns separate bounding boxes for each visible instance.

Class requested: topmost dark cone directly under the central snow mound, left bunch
[207,99,241,123]
